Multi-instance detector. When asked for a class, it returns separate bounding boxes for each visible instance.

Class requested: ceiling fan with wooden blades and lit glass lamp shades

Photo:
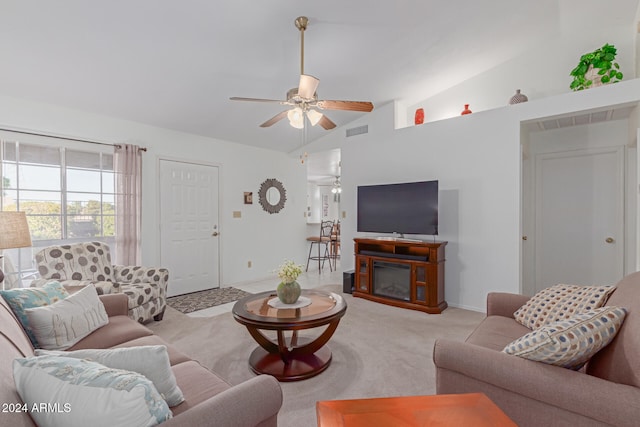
[229,16,373,129]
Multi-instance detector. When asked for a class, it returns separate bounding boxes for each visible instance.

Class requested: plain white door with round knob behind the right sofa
[534,147,624,292]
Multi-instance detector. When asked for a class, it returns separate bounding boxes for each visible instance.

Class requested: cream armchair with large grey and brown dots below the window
[31,242,169,323]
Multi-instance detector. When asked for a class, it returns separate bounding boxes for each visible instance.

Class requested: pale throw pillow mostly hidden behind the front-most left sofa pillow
[36,345,184,407]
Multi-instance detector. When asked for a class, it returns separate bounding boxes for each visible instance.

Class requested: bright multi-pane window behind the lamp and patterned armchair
[0,137,115,284]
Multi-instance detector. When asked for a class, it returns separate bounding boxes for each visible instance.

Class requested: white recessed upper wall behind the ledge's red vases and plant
[404,26,636,127]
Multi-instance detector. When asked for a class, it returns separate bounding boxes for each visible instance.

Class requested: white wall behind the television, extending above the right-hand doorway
[298,79,640,310]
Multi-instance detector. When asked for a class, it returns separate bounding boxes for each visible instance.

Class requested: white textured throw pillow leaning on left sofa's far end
[25,285,109,350]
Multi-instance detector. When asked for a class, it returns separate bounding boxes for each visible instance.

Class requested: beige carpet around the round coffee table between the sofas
[148,285,484,427]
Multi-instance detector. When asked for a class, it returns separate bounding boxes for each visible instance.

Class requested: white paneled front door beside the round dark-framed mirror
[159,160,220,296]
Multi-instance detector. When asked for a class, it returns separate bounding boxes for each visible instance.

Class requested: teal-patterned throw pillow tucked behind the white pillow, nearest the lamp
[0,282,69,347]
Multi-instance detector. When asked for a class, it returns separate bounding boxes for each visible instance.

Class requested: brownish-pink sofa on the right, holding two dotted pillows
[433,272,640,427]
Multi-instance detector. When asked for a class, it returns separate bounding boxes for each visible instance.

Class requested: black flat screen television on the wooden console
[358,181,438,235]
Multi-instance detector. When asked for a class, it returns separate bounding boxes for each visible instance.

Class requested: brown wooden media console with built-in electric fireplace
[353,238,447,314]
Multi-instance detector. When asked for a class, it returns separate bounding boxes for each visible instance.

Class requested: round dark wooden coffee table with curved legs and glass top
[232,289,347,381]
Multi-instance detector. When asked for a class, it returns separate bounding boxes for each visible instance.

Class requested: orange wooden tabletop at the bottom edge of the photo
[316,393,517,427]
